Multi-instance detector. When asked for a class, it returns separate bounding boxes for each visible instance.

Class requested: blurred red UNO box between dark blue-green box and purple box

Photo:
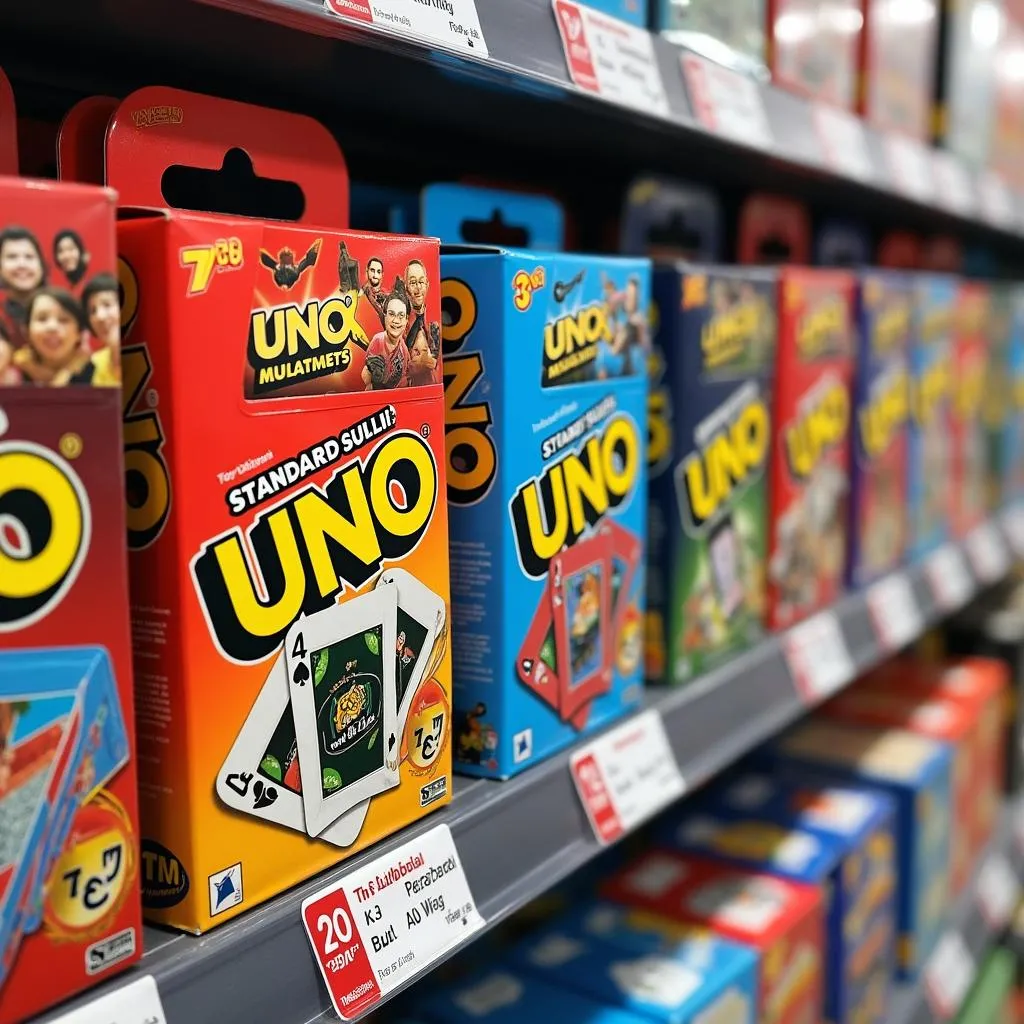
[768,267,855,630]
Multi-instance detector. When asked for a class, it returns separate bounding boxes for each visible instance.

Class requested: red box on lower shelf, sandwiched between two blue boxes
[603,850,824,1024]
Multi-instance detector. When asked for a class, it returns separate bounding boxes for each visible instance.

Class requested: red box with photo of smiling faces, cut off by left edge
[0,176,142,1024]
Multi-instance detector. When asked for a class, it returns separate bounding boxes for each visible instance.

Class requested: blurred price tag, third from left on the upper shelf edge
[680,52,774,151]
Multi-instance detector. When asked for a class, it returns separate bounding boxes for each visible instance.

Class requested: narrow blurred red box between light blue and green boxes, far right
[949,281,989,538]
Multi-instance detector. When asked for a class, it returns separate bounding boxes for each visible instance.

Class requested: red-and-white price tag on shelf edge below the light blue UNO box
[569,709,686,845]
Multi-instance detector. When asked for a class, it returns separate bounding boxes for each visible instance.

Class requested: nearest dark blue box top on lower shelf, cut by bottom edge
[414,968,643,1024]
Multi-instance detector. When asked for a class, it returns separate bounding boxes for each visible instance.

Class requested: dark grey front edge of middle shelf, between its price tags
[36,513,1024,1024]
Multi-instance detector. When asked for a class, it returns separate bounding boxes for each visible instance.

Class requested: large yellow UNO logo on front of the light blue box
[509,414,641,579]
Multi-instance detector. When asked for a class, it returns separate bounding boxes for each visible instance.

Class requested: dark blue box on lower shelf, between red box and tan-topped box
[660,774,896,1024]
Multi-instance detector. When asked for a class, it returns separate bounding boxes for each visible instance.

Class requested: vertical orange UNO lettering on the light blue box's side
[441,278,498,505]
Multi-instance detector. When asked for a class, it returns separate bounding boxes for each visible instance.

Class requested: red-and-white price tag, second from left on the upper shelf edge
[552,0,671,118]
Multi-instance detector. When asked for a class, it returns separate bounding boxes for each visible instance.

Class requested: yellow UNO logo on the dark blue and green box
[677,397,770,531]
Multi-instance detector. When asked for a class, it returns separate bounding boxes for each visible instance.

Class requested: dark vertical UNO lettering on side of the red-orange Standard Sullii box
[118,253,171,551]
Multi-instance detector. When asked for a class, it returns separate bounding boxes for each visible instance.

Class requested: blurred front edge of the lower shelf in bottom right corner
[889,800,1024,1024]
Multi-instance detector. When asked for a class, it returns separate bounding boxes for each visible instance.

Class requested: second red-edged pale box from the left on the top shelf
[858,0,939,141]
